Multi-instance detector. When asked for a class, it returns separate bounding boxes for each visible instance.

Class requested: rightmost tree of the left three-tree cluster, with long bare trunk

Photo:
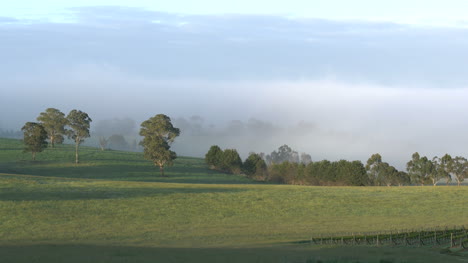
[67,110,92,163]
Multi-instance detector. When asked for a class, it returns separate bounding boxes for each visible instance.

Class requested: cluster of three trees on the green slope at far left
[21,108,92,163]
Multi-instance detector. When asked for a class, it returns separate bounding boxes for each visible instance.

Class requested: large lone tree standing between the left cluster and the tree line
[140,114,180,176]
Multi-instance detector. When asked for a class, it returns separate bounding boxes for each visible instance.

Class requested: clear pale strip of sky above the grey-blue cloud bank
[0,0,468,26]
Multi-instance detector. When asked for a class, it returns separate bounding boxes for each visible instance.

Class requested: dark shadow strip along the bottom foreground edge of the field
[0,245,459,263]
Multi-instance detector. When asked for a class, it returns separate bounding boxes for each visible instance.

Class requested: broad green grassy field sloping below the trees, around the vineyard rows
[0,139,468,262]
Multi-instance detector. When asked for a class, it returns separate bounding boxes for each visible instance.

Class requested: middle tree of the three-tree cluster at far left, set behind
[37,108,67,148]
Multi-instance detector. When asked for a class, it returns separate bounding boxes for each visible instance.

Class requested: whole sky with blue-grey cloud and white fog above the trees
[0,0,468,169]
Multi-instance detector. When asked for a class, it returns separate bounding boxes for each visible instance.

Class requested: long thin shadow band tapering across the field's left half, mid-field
[0,187,245,202]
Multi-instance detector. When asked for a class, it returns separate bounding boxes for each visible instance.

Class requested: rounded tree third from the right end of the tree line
[406,152,435,185]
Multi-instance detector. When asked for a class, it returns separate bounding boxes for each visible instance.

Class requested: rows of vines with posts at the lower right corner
[310,226,468,249]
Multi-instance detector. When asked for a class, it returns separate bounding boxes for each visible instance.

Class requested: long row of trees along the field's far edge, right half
[205,145,468,186]
